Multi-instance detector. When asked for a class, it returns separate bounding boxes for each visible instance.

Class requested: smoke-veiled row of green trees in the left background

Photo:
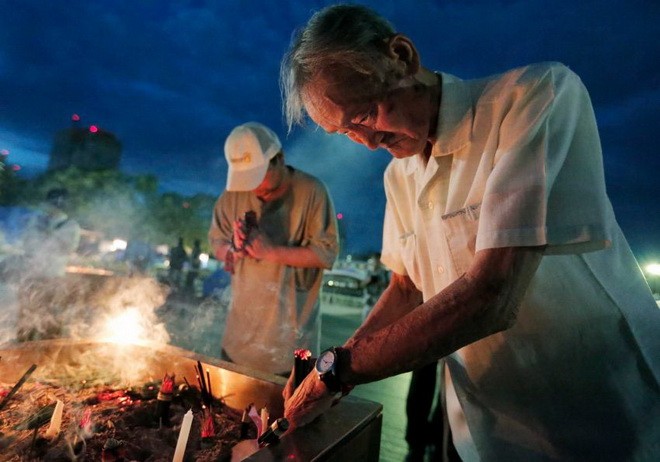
[0,167,215,253]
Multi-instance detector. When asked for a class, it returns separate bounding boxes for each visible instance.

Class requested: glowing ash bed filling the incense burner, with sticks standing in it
[0,381,257,462]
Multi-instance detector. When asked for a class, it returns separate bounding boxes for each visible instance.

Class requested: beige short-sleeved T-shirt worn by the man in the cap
[209,167,338,373]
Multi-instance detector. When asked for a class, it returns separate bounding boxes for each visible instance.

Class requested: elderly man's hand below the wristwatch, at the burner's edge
[284,366,335,432]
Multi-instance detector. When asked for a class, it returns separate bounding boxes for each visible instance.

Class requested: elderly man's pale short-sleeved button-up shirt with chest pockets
[382,64,660,461]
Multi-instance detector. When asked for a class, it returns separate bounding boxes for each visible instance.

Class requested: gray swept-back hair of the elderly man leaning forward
[280,5,396,131]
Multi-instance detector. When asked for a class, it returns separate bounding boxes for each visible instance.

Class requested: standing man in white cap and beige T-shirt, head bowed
[209,122,338,375]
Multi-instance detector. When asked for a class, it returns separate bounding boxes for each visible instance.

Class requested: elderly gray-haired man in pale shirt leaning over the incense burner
[281,6,660,461]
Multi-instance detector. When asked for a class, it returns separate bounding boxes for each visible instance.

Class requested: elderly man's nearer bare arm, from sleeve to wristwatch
[340,249,542,384]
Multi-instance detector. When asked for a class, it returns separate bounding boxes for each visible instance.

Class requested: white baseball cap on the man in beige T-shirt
[225,122,282,191]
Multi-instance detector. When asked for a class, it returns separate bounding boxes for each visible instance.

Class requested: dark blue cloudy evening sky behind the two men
[0,0,660,262]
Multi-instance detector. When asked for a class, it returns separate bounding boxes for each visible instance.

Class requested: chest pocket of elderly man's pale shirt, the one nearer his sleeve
[442,203,481,275]
